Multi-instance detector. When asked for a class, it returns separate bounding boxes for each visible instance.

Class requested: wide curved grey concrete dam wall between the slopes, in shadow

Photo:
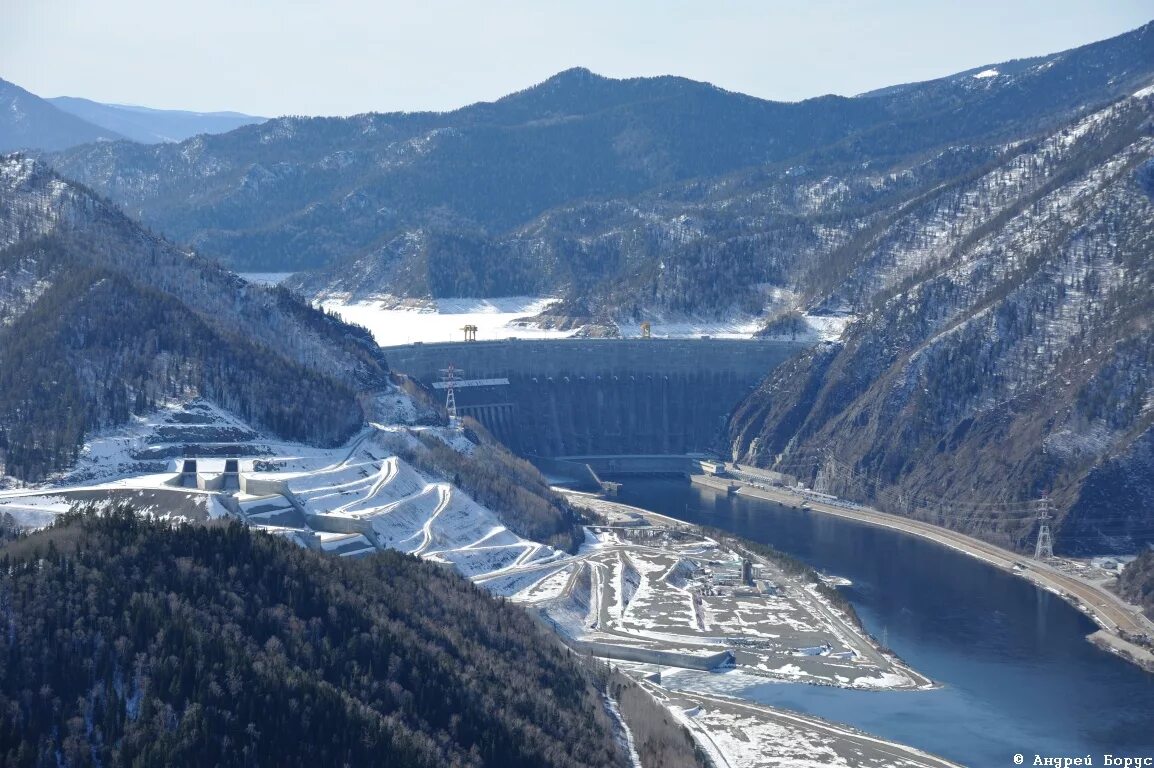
[384,339,807,457]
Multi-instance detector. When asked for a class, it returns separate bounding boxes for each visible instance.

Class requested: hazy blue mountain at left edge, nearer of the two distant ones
[0,80,123,152]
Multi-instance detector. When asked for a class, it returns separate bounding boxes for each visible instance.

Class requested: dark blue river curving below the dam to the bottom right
[620,477,1154,767]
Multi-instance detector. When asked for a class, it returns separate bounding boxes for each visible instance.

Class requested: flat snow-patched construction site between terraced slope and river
[478,494,932,688]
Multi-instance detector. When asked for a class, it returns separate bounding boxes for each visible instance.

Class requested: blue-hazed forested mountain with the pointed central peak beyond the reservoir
[42,70,878,271]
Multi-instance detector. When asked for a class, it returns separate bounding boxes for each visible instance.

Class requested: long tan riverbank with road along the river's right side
[710,467,1154,672]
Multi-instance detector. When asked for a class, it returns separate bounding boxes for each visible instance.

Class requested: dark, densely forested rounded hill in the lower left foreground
[0,506,632,768]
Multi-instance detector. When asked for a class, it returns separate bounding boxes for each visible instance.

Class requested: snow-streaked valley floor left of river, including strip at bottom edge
[544,492,954,768]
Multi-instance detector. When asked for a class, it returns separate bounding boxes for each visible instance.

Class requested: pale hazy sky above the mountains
[0,0,1154,115]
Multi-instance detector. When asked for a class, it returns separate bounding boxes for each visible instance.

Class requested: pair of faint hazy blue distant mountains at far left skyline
[0,80,264,152]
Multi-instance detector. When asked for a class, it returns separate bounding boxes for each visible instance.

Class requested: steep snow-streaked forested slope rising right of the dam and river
[729,89,1154,551]
